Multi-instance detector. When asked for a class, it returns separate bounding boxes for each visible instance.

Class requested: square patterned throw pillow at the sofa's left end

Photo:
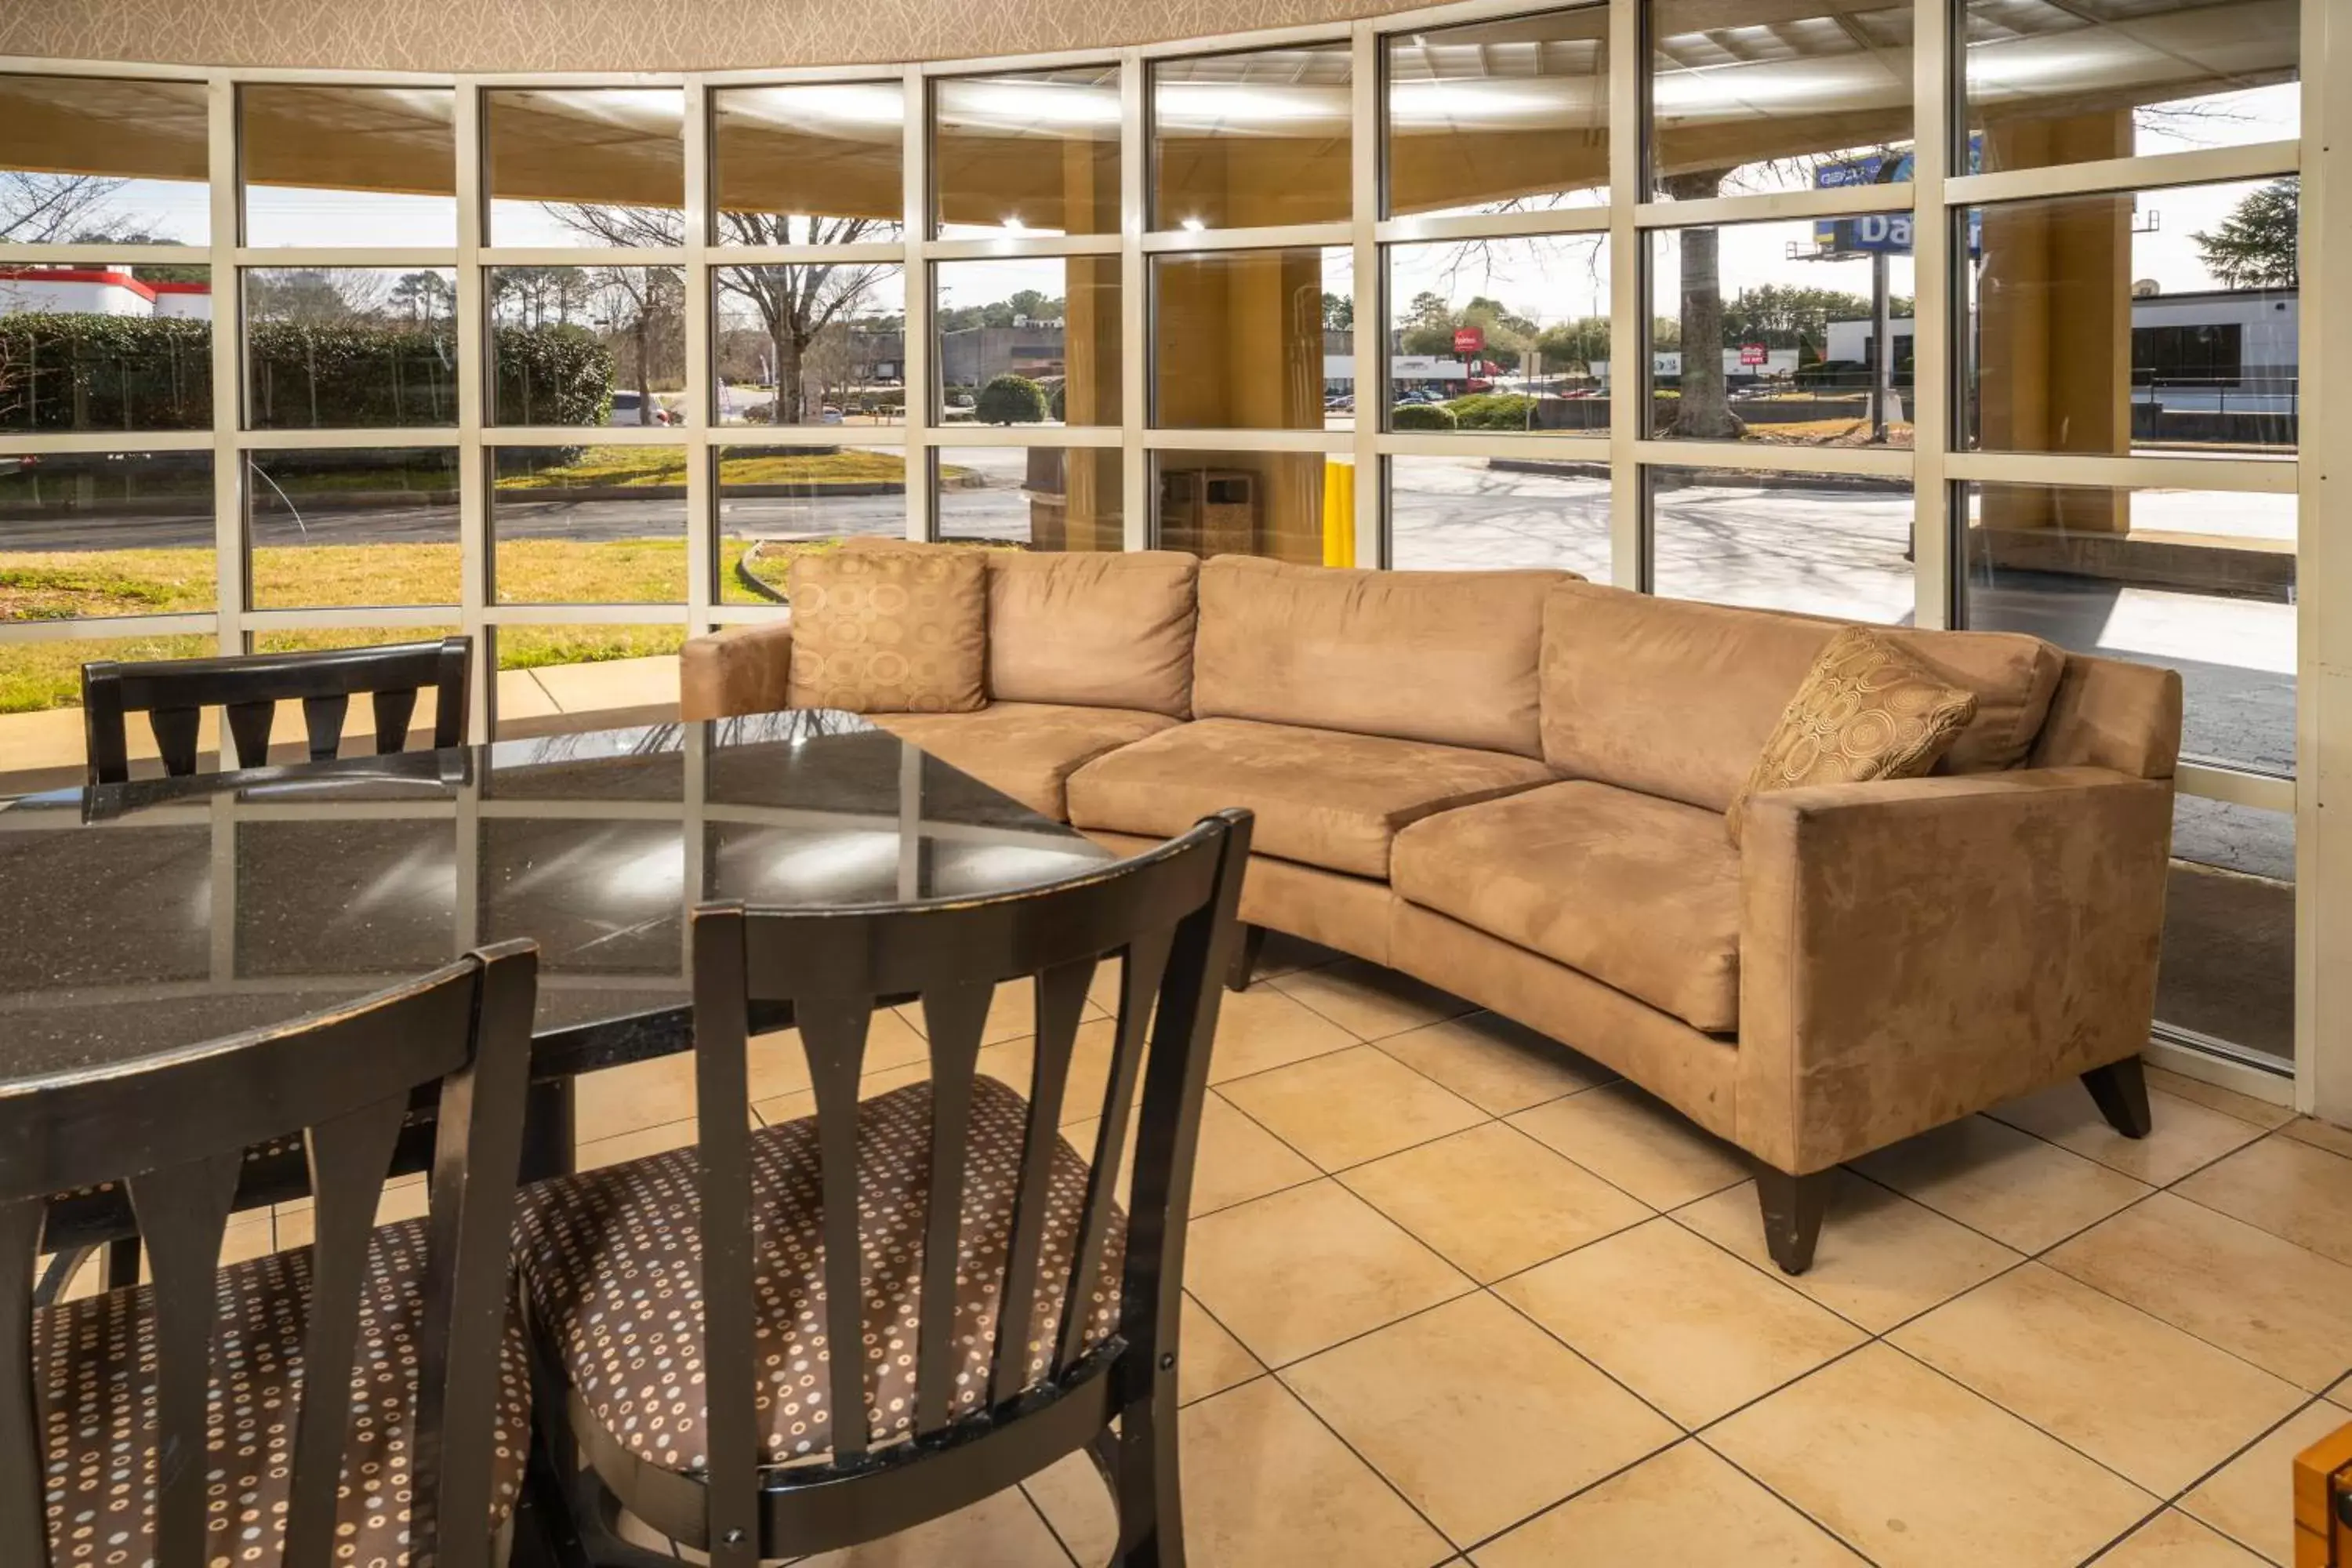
[786,550,988,713]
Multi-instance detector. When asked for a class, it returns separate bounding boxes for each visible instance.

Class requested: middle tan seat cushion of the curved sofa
[1070,720,1562,877]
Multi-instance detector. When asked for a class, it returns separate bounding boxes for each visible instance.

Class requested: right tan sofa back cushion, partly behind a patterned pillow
[1543,583,2065,811]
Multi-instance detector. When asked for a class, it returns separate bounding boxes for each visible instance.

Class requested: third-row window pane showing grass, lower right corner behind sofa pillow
[717,447,906,604]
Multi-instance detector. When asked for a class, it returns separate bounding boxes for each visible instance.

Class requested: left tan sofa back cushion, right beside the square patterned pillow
[985,550,1200,720]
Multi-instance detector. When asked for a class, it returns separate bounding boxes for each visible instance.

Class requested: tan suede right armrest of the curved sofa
[1736,767,2173,1175]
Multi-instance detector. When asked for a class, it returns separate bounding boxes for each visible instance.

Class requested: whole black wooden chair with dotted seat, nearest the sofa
[517,811,1251,1568]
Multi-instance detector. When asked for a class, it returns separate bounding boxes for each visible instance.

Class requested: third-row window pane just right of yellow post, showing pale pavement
[1388,459,1611,583]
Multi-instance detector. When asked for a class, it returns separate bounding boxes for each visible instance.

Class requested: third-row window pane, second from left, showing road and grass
[245,447,459,609]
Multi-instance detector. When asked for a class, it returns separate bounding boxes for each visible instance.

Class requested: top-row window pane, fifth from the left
[931,66,1120,238]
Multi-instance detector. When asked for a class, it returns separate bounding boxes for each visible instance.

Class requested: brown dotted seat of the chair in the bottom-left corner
[33,1220,532,1568]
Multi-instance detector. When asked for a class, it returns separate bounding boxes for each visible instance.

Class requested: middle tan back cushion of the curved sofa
[1192,555,1571,761]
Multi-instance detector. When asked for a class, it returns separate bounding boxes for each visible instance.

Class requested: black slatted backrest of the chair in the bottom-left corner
[0,942,539,1568]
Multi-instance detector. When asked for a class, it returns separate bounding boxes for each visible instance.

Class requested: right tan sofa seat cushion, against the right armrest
[1390,781,1740,1034]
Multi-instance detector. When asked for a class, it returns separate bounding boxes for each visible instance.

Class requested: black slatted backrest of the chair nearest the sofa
[694,811,1251,1568]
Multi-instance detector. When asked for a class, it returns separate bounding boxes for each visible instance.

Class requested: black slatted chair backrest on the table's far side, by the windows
[82,637,473,785]
